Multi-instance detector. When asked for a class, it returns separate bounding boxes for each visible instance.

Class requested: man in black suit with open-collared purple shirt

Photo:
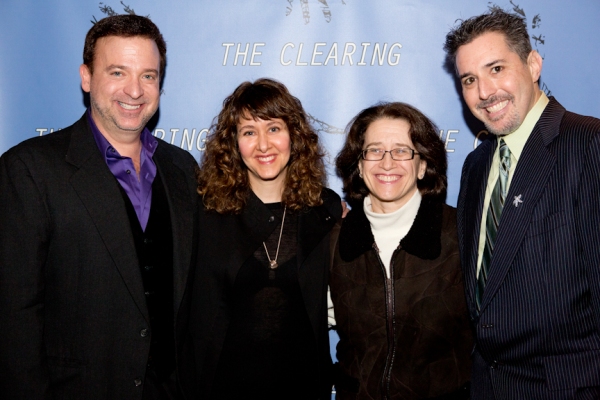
[0,15,196,400]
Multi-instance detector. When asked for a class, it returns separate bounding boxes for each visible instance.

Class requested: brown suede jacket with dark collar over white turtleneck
[329,197,473,399]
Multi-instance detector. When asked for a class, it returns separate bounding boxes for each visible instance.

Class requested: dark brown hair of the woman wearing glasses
[335,102,448,203]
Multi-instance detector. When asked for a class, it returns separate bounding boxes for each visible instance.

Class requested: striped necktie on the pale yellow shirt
[475,139,510,310]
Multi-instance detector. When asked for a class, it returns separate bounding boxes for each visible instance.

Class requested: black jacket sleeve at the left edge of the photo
[0,152,50,400]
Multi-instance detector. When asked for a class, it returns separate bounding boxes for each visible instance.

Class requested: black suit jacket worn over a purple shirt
[0,115,197,399]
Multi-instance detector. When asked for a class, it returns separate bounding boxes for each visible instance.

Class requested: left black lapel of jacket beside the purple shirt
[65,115,149,321]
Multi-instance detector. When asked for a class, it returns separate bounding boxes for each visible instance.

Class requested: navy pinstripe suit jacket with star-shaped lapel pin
[458,98,600,400]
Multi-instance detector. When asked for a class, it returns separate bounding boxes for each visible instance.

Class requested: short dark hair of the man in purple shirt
[83,14,167,80]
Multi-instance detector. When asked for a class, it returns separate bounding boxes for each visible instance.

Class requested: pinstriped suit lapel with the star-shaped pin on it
[481,100,564,311]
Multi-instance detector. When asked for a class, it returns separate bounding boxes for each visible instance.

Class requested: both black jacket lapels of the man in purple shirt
[65,114,195,321]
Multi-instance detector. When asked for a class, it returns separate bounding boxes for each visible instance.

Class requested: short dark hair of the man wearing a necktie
[444,8,531,65]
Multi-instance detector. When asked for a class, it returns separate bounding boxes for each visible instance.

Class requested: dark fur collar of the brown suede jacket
[339,196,443,261]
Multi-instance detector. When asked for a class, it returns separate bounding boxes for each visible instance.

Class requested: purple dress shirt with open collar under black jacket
[87,109,158,231]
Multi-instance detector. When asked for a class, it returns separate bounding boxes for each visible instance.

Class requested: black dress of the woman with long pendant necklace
[211,203,318,399]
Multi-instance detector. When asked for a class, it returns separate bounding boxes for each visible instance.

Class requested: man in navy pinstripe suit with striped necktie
[445,7,600,400]
